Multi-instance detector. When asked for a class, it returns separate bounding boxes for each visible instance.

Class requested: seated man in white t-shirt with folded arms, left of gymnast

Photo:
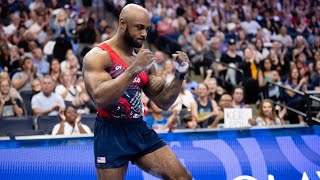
[31,75,65,116]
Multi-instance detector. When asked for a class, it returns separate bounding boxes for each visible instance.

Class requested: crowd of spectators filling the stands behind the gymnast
[0,0,320,135]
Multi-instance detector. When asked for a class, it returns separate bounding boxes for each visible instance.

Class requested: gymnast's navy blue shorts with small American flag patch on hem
[94,117,166,169]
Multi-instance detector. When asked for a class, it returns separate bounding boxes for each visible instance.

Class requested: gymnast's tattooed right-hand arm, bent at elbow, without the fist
[143,67,182,110]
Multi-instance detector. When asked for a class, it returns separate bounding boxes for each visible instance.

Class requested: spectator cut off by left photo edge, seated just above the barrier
[0,79,24,117]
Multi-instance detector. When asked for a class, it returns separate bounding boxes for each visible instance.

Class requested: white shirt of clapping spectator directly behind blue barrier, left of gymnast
[51,122,92,135]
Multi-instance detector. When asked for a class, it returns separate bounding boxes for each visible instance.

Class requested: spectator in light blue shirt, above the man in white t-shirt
[32,48,50,75]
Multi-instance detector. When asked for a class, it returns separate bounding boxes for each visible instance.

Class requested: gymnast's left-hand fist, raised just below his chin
[134,49,155,72]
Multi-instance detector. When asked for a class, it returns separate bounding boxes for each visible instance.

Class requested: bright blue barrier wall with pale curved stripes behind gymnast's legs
[0,126,320,180]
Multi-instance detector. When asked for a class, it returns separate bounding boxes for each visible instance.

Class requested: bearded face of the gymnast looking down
[124,17,151,48]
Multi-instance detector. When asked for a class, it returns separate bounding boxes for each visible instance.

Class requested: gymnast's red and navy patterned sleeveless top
[97,43,148,120]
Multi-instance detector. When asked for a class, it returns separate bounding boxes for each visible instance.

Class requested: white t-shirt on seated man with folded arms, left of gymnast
[31,92,66,116]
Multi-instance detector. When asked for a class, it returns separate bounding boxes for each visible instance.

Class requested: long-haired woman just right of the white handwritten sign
[249,99,283,126]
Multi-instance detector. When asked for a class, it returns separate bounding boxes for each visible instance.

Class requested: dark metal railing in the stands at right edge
[267,82,320,126]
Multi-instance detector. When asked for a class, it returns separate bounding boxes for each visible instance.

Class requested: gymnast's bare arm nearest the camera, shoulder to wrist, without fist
[83,48,139,107]
